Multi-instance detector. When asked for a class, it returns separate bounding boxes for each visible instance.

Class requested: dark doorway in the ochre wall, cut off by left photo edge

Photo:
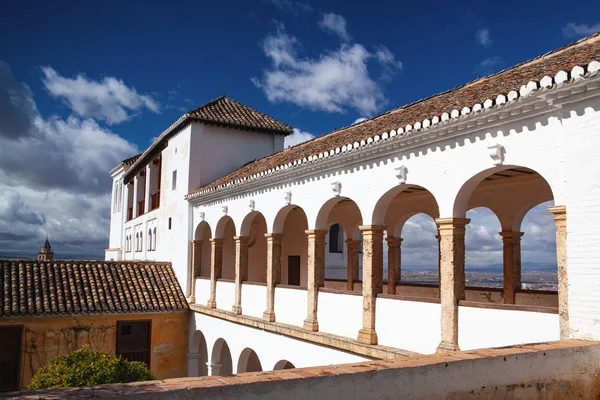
[0,326,23,391]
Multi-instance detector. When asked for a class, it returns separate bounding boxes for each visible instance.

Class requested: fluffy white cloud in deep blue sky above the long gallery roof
[252,25,401,115]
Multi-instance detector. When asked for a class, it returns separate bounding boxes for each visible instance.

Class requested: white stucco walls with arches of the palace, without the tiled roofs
[106,56,600,373]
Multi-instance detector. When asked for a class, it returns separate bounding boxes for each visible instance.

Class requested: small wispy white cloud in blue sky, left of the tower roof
[42,67,160,124]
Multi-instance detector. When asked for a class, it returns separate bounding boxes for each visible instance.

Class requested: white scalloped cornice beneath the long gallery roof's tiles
[185,61,600,205]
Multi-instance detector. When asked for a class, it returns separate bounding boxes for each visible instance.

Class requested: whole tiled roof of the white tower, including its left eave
[124,95,294,181]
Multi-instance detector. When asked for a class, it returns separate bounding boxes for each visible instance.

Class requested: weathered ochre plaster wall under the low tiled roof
[0,311,188,387]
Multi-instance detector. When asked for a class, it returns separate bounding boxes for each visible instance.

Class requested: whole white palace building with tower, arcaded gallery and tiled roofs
[106,34,600,382]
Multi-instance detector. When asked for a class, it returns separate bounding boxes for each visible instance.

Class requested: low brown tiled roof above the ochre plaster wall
[0,260,188,318]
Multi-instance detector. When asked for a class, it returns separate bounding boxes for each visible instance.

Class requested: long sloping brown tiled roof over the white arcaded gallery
[187,33,600,198]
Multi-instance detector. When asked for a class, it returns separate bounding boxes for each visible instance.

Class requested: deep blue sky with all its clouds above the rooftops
[0,0,600,260]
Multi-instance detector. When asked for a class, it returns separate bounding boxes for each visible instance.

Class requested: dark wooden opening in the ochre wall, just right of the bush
[116,321,150,368]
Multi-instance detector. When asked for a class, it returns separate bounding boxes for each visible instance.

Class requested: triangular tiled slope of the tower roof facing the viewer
[188,96,293,135]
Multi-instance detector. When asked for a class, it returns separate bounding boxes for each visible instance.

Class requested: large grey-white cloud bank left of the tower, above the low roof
[0,64,138,257]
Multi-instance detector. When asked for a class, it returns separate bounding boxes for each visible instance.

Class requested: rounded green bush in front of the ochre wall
[27,345,155,390]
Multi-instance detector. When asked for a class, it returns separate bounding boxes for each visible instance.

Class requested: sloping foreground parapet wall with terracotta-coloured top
[10,340,600,400]
